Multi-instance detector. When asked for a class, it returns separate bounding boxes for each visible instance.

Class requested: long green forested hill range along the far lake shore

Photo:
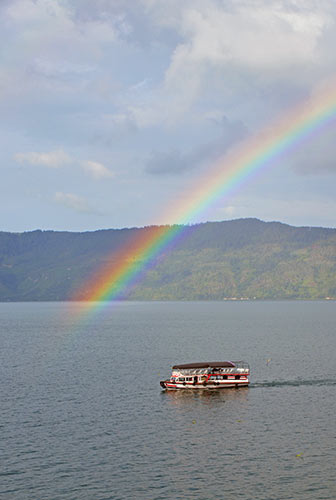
[0,219,336,301]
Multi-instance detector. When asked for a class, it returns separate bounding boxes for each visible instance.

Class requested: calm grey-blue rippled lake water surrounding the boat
[0,302,336,500]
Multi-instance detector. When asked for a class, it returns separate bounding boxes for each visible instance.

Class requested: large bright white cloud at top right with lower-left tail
[128,0,336,127]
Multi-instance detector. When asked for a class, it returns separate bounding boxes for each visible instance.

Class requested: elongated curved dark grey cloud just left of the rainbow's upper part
[145,116,248,175]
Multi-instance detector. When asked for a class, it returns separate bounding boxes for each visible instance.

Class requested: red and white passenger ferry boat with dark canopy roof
[160,361,250,390]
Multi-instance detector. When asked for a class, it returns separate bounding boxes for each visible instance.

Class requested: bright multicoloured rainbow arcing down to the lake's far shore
[72,85,336,310]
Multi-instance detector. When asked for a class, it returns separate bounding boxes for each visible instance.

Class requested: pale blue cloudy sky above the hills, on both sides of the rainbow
[0,0,336,232]
